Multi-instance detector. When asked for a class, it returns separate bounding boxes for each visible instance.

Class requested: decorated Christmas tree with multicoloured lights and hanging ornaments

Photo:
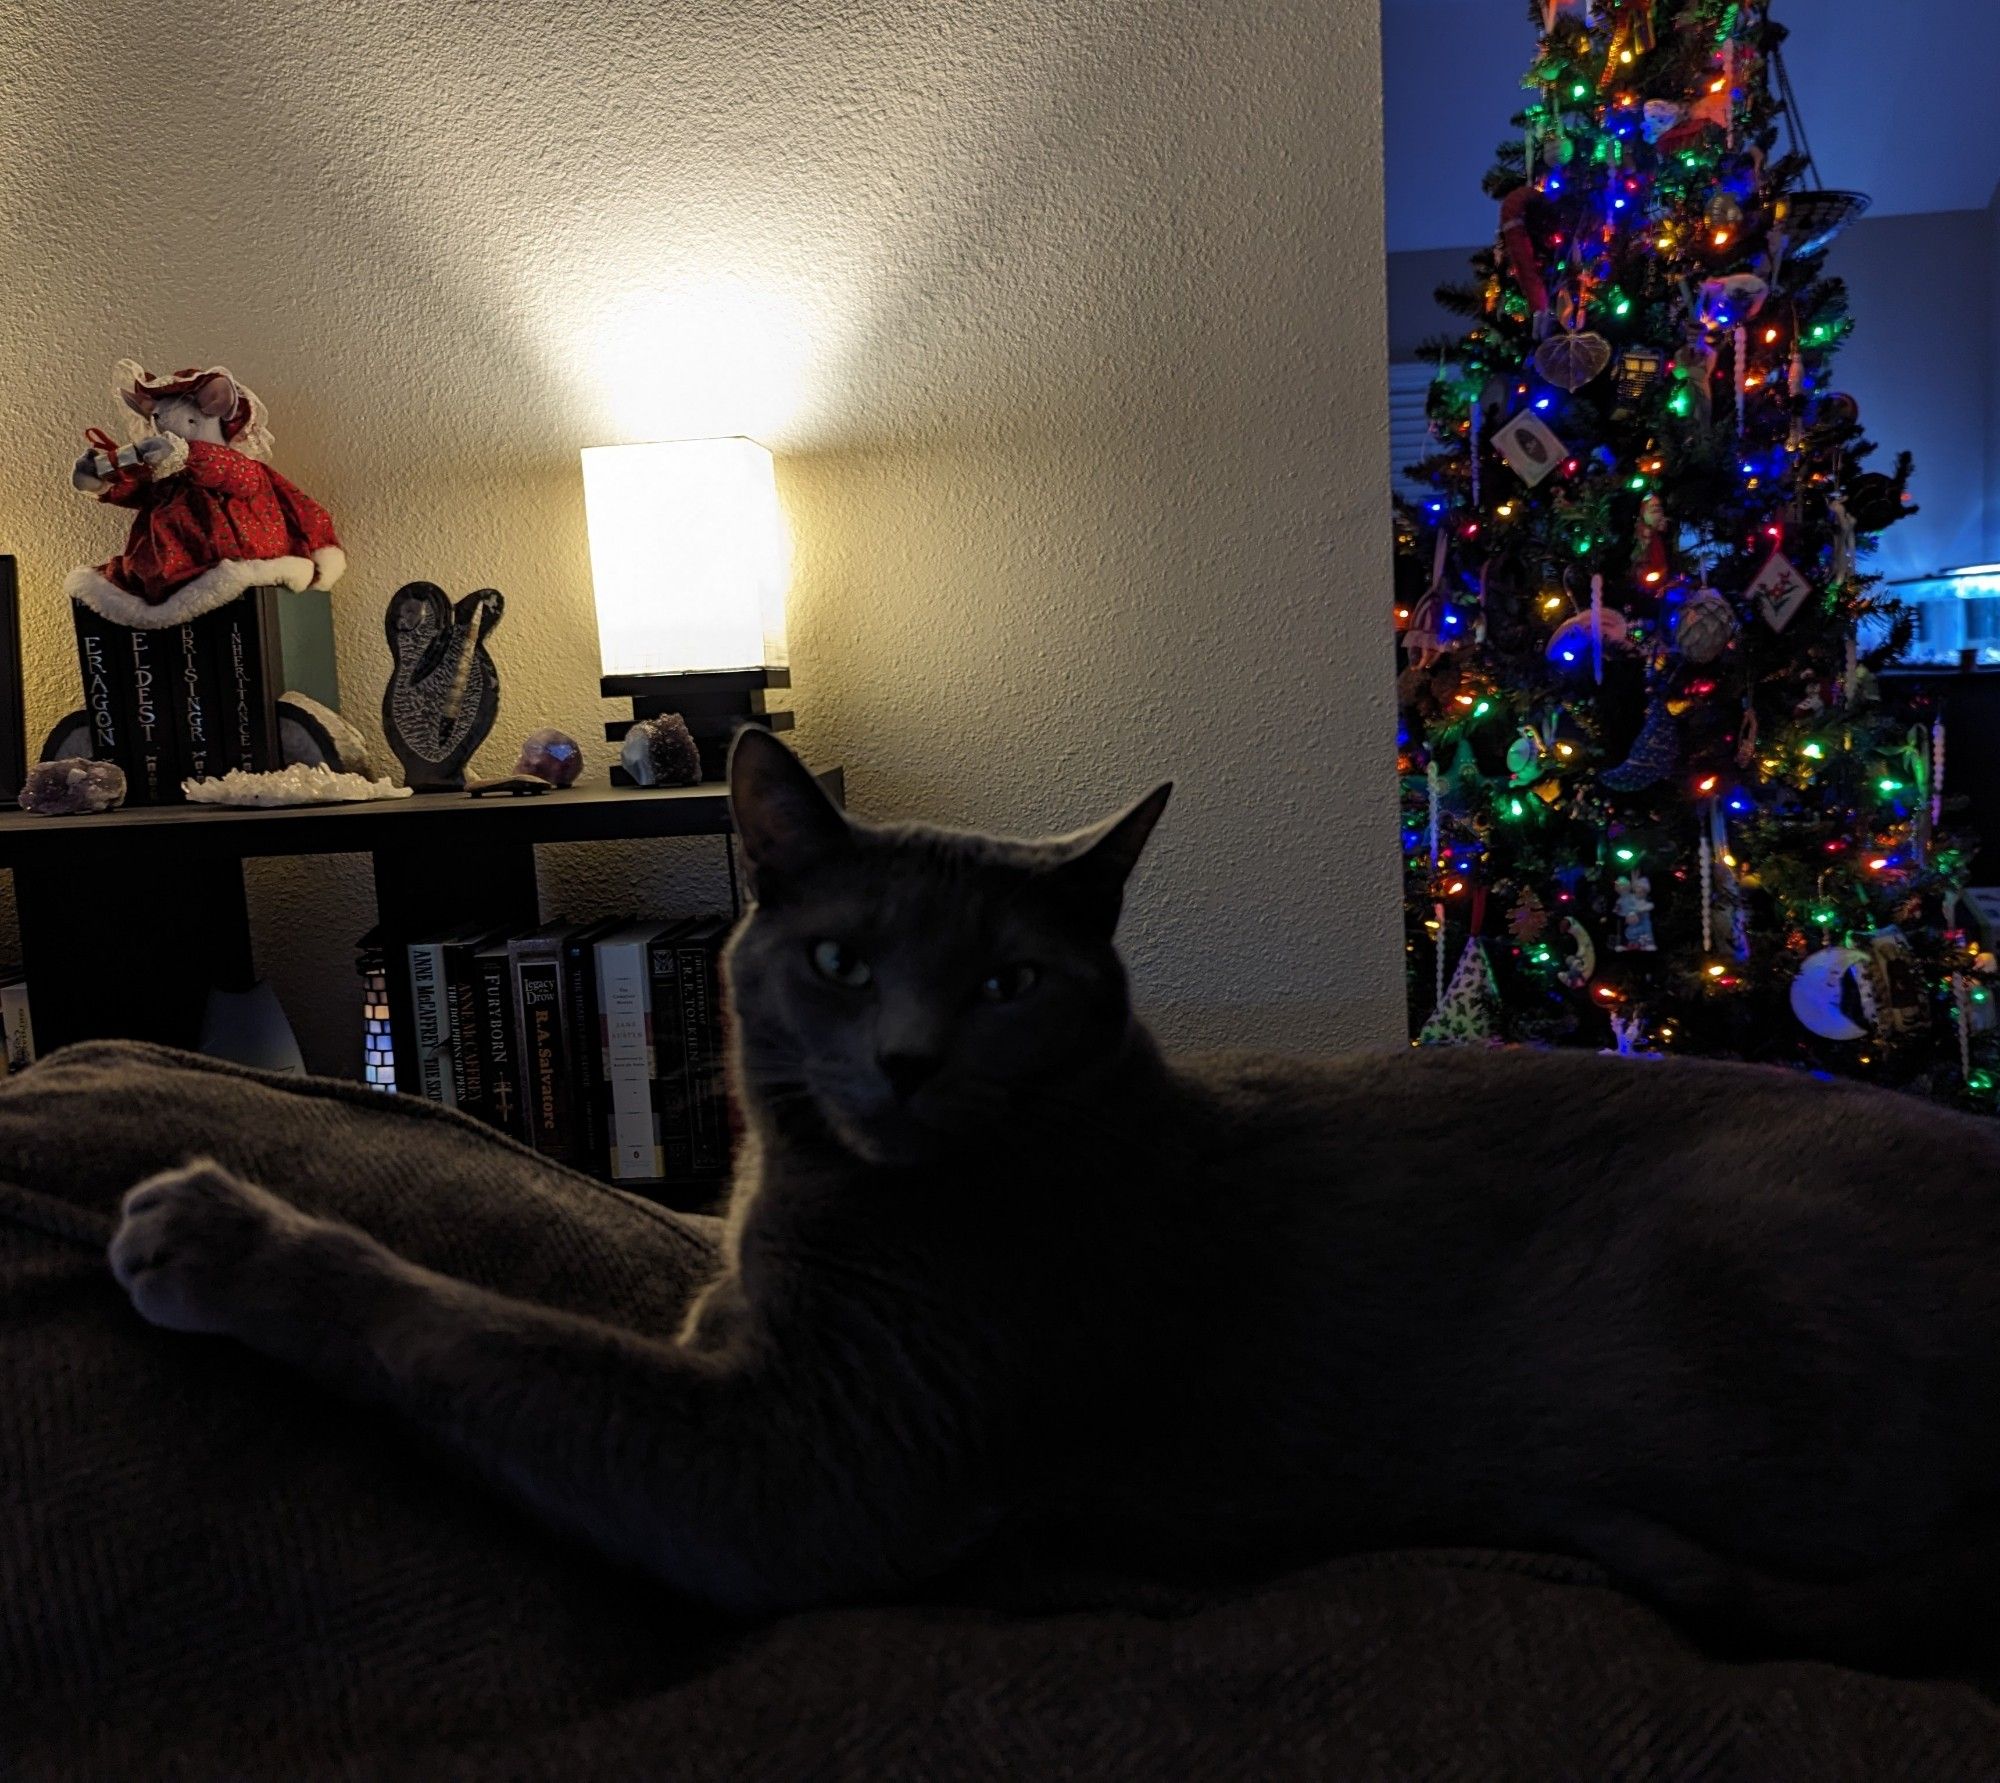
[1396,0,1994,1107]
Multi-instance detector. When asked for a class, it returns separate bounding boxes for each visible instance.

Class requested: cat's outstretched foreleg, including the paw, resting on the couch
[110,1163,960,1611]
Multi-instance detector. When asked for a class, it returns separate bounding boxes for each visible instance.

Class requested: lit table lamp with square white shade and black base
[582,440,792,786]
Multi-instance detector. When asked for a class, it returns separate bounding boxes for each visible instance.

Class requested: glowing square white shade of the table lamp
[584,440,792,676]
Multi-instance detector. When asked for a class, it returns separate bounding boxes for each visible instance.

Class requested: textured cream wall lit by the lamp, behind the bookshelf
[0,0,1402,1069]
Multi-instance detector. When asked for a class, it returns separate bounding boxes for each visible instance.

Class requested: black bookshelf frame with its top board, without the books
[0,768,846,1051]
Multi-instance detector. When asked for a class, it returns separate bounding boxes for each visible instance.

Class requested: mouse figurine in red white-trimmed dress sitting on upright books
[64,360,348,630]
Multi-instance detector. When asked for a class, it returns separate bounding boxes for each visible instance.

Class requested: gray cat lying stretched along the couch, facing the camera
[110,730,2000,1655]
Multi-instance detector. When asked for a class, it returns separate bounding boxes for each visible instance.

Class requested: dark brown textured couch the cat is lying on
[0,1043,2000,1783]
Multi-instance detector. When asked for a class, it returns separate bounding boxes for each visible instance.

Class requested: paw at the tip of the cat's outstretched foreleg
[110,1157,312,1333]
